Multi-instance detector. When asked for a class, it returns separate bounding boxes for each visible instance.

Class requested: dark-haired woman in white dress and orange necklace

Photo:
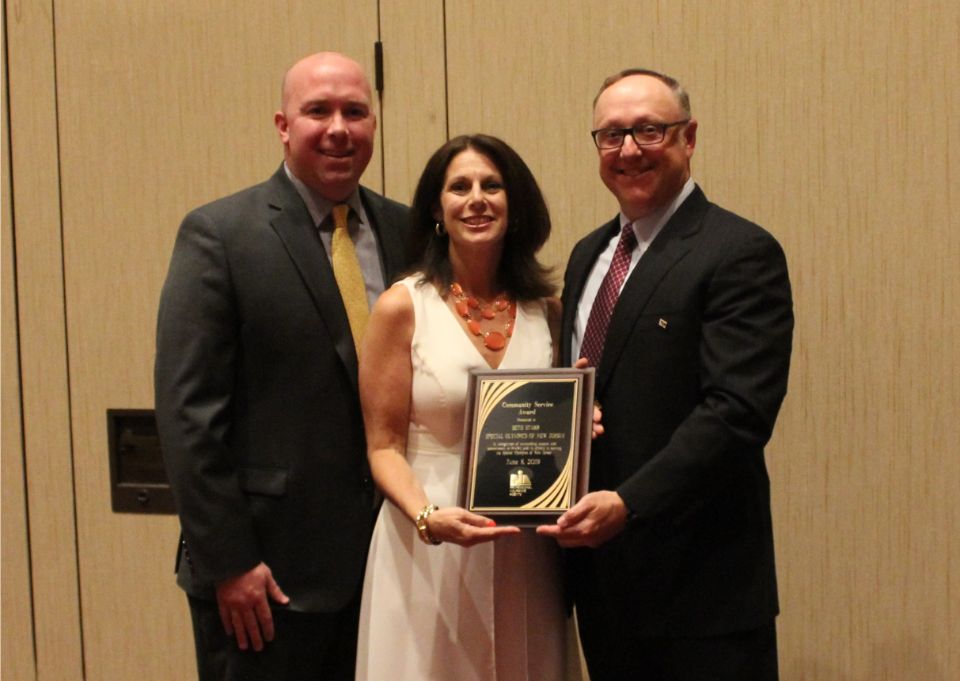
[357,135,565,681]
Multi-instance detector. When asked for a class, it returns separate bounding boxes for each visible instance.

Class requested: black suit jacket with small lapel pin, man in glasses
[562,187,793,635]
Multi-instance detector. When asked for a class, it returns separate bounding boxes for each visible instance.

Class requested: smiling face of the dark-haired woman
[437,149,507,249]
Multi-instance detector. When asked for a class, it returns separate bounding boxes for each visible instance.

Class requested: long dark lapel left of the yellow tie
[270,167,359,392]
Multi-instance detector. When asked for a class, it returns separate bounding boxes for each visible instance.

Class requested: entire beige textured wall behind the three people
[2,0,960,681]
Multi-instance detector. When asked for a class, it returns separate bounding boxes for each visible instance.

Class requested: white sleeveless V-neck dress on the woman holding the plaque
[356,277,566,681]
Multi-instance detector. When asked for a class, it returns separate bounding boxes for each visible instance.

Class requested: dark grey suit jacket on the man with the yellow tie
[155,166,408,612]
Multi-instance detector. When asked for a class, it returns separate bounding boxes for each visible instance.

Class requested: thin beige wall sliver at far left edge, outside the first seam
[0,22,37,681]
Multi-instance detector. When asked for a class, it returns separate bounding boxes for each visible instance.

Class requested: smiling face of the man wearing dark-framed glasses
[593,75,697,220]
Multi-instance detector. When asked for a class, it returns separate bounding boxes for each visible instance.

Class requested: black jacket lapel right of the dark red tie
[597,187,709,392]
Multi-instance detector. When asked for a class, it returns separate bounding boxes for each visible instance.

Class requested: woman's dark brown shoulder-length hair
[409,135,556,300]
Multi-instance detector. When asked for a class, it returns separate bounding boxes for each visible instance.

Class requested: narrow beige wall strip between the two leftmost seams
[4,0,83,681]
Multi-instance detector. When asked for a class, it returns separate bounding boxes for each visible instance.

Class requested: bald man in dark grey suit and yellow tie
[155,53,407,681]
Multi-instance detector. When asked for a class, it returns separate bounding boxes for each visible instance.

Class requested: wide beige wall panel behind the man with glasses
[446,0,960,681]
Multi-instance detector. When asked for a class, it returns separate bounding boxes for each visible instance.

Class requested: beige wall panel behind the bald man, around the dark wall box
[49,0,382,681]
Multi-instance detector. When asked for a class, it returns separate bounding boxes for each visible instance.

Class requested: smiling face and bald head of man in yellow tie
[274,52,377,201]
